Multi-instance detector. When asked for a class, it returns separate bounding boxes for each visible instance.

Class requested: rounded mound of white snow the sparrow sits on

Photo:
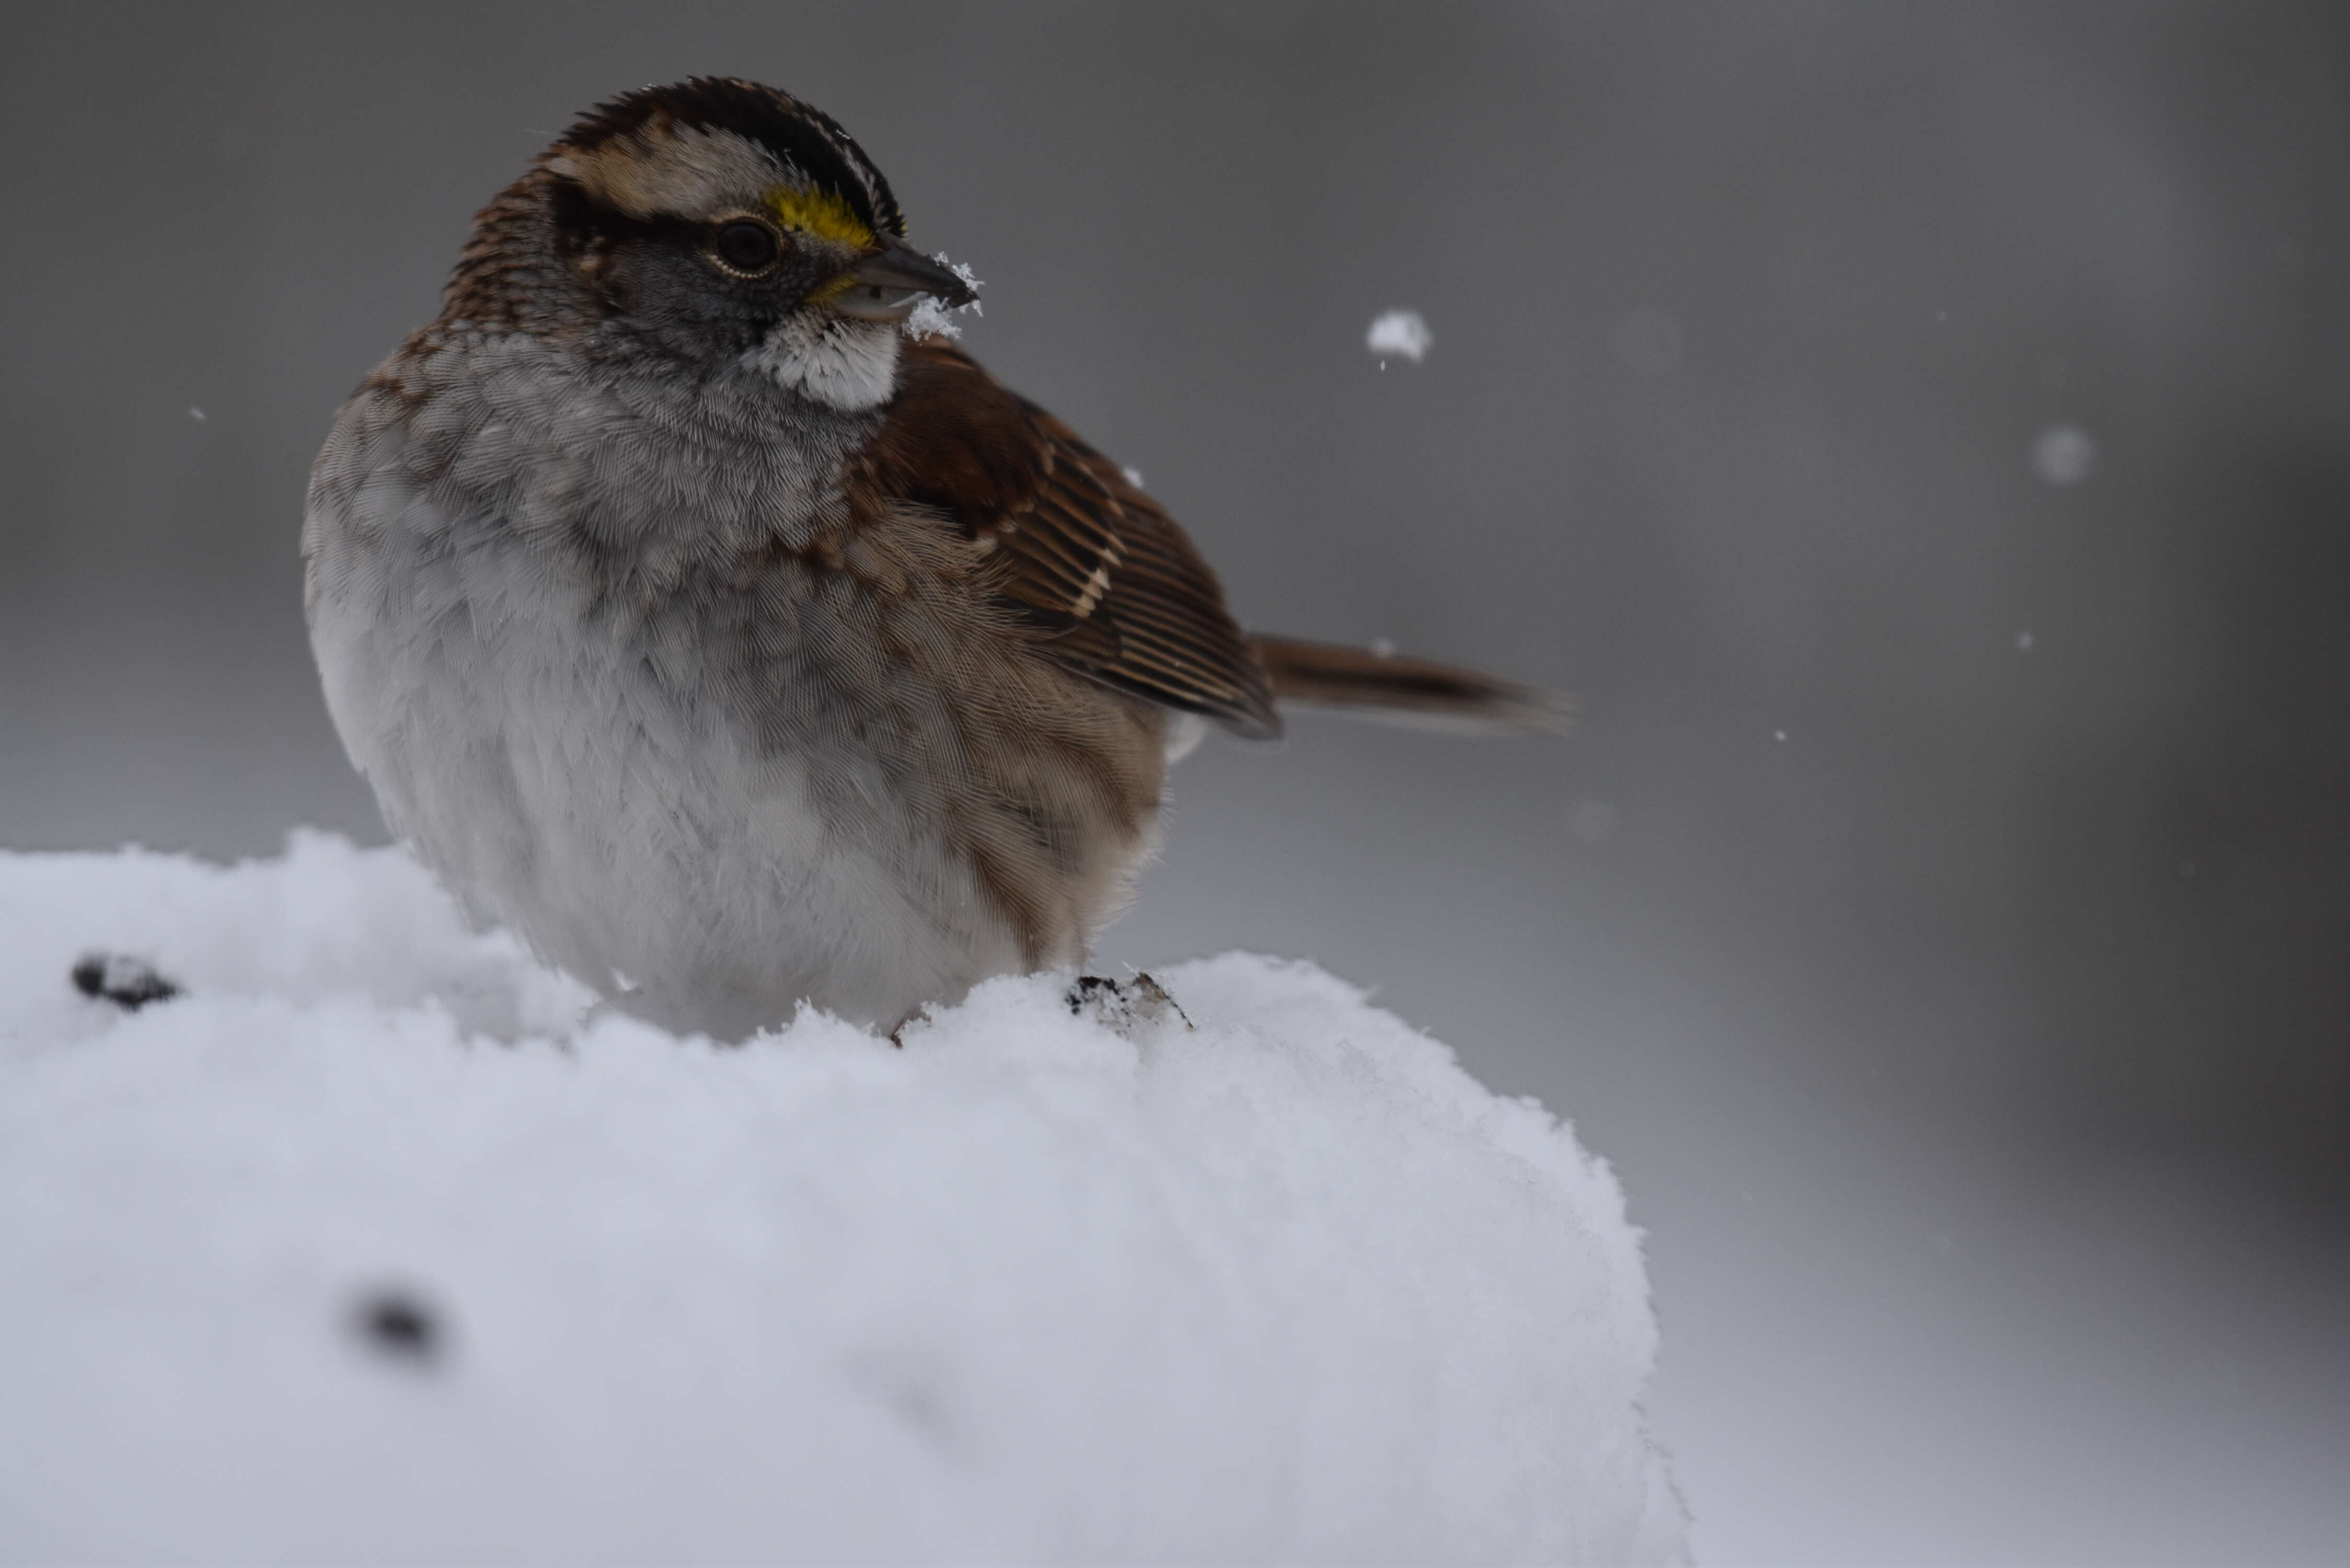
[0,835,1683,1563]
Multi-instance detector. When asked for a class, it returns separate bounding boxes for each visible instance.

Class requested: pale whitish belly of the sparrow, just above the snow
[313,512,1034,1037]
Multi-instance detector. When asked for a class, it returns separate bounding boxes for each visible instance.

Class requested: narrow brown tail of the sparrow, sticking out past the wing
[1248,637,1574,736]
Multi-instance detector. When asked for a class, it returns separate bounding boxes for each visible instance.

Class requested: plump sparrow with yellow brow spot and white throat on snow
[303,77,1568,1042]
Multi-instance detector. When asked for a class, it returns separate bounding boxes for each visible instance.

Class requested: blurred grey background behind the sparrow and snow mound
[0,0,2350,1563]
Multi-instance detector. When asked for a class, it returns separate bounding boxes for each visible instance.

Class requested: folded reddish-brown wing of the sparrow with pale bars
[856,341,1281,736]
